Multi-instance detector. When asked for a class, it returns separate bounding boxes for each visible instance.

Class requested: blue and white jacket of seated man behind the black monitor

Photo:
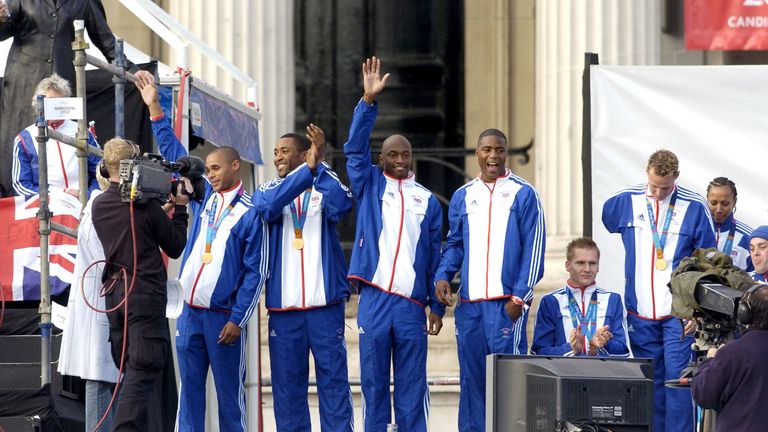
[531,284,629,357]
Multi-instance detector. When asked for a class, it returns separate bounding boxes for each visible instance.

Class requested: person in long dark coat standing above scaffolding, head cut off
[0,0,151,193]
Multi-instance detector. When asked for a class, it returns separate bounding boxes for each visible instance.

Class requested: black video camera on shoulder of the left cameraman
[119,153,205,204]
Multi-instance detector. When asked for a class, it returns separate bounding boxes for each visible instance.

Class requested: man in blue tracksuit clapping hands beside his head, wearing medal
[254,125,354,431]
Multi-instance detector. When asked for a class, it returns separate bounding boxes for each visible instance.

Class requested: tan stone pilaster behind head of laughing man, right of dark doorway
[464,0,535,183]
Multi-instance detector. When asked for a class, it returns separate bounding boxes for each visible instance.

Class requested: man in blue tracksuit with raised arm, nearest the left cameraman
[137,81,268,431]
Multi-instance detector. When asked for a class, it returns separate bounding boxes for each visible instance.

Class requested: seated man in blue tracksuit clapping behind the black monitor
[531,237,629,357]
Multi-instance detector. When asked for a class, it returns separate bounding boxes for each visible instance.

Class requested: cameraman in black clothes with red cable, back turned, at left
[93,138,191,431]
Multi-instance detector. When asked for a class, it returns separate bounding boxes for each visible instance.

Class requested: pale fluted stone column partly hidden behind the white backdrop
[534,0,661,280]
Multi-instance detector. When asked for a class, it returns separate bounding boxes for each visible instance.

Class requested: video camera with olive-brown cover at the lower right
[669,248,757,351]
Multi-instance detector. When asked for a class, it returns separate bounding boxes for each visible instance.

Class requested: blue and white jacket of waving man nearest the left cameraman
[152,117,269,327]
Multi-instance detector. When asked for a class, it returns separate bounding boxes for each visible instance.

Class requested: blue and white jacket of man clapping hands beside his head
[254,162,352,311]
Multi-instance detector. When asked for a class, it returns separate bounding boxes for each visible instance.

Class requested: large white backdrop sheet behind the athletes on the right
[590,66,768,294]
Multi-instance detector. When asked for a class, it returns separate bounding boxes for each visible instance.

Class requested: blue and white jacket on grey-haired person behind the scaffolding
[11,120,101,196]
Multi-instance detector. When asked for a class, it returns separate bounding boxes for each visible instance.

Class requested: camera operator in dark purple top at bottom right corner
[691,285,768,432]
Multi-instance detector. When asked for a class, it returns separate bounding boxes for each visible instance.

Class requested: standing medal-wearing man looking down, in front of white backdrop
[603,150,715,432]
